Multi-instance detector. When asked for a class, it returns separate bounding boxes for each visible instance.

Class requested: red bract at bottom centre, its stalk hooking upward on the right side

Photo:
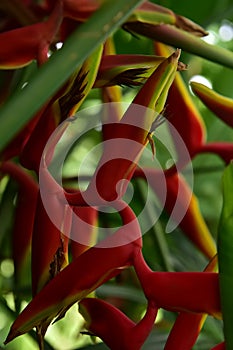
[79,298,157,350]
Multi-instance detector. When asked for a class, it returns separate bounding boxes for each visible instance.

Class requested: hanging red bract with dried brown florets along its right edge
[32,196,71,295]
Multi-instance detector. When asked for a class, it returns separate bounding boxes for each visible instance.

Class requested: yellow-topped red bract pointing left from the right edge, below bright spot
[190,82,233,127]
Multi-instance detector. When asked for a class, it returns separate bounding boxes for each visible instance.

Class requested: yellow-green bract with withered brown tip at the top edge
[125,1,208,36]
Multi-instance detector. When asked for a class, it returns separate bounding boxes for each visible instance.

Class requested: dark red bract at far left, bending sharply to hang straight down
[0,161,38,287]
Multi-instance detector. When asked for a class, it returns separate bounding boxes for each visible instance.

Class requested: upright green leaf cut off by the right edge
[218,162,233,350]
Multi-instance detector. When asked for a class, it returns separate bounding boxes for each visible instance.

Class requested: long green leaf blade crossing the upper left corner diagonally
[0,0,142,149]
